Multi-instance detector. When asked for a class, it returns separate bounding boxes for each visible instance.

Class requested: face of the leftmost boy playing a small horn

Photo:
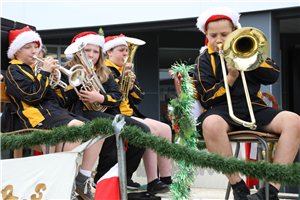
[15,42,39,66]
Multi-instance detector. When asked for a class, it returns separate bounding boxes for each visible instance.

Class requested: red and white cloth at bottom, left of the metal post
[95,163,121,200]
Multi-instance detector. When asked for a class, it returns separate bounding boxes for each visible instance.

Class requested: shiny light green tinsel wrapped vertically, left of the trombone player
[168,62,198,200]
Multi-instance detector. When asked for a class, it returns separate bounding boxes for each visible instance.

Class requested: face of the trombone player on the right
[205,20,233,52]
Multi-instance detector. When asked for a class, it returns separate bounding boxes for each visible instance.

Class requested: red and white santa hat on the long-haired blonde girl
[66,31,104,60]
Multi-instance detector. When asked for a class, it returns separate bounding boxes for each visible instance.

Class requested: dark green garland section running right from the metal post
[121,126,300,186]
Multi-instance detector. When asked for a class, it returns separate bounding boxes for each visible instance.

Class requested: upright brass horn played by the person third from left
[119,37,146,101]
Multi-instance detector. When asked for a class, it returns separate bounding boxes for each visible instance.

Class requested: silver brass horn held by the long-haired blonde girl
[64,41,107,112]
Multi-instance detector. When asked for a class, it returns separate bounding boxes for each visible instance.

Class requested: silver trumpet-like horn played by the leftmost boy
[33,56,85,89]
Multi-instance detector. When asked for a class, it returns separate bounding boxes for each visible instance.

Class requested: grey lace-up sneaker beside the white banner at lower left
[75,172,94,200]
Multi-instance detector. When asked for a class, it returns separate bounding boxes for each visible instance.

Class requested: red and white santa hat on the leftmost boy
[7,27,42,59]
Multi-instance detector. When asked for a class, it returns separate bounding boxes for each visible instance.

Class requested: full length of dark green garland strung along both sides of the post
[0,118,300,186]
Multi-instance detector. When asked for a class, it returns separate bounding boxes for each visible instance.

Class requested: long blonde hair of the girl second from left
[66,46,109,83]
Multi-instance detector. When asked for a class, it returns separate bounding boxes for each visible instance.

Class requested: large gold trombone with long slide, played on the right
[218,27,269,130]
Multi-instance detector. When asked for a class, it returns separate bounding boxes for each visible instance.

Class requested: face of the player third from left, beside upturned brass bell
[107,45,128,67]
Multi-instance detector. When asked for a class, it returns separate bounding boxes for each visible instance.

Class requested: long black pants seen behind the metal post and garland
[83,111,150,183]
